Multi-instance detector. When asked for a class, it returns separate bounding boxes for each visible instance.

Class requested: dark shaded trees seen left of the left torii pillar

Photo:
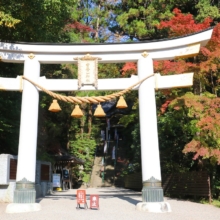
[0,62,22,155]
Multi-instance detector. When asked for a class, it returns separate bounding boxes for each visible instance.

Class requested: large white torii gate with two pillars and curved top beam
[0,29,212,212]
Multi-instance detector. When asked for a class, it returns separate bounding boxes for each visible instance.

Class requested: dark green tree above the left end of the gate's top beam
[0,0,76,42]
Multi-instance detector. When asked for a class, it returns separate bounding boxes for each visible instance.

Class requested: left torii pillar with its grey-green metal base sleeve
[14,59,40,205]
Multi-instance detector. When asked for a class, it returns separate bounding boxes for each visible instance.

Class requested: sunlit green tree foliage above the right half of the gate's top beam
[110,0,220,40]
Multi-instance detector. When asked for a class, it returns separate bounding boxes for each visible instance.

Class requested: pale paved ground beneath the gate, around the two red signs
[0,187,220,220]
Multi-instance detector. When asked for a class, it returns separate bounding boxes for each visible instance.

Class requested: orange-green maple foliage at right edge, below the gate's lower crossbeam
[171,94,220,164]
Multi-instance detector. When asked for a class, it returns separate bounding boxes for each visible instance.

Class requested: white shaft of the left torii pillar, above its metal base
[16,59,40,182]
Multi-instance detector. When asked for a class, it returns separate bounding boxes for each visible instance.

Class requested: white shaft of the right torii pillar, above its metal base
[138,55,161,181]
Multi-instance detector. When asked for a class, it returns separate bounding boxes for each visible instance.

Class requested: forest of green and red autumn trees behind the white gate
[0,0,220,197]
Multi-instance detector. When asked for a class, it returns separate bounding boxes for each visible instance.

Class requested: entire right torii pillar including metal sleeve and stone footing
[136,55,169,212]
